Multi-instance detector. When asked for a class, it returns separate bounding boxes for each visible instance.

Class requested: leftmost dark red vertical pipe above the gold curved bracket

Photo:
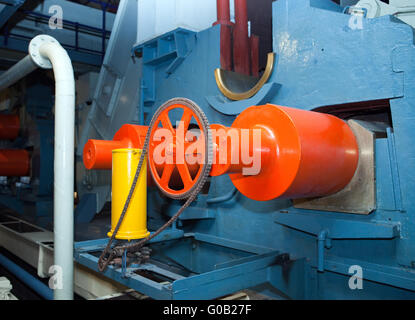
[213,0,233,71]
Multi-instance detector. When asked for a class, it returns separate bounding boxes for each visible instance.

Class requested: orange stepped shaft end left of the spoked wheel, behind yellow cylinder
[83,124,148,170]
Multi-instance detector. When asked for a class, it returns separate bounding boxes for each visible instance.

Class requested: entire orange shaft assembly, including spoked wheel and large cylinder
[84,104,359,201]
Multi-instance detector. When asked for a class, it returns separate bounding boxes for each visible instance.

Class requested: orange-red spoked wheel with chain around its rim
[148,98,213,199]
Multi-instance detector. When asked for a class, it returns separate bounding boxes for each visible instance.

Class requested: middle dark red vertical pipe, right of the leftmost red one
[233,0,251,76]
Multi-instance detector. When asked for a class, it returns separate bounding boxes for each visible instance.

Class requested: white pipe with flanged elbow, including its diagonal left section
[0,35,75,300]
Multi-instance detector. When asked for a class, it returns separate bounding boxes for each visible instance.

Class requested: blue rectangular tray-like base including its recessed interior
[75,229,290,300]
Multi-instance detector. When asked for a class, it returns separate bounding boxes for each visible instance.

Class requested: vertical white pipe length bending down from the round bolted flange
[39,38,75,300]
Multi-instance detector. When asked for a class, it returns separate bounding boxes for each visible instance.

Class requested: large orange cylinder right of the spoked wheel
[226,104,359,201]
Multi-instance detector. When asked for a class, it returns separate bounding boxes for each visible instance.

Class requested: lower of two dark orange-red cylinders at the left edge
[0,150,30,177]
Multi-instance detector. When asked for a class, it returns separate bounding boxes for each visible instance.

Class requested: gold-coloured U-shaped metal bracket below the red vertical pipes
[215,52,275,101]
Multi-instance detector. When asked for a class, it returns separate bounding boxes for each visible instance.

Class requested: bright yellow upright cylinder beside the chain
[108,149,150,240]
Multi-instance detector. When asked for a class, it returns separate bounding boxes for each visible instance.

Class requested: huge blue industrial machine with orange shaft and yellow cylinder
[0,0,415,300]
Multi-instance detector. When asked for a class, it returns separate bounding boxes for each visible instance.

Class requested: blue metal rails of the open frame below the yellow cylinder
[75,229,289,300]
